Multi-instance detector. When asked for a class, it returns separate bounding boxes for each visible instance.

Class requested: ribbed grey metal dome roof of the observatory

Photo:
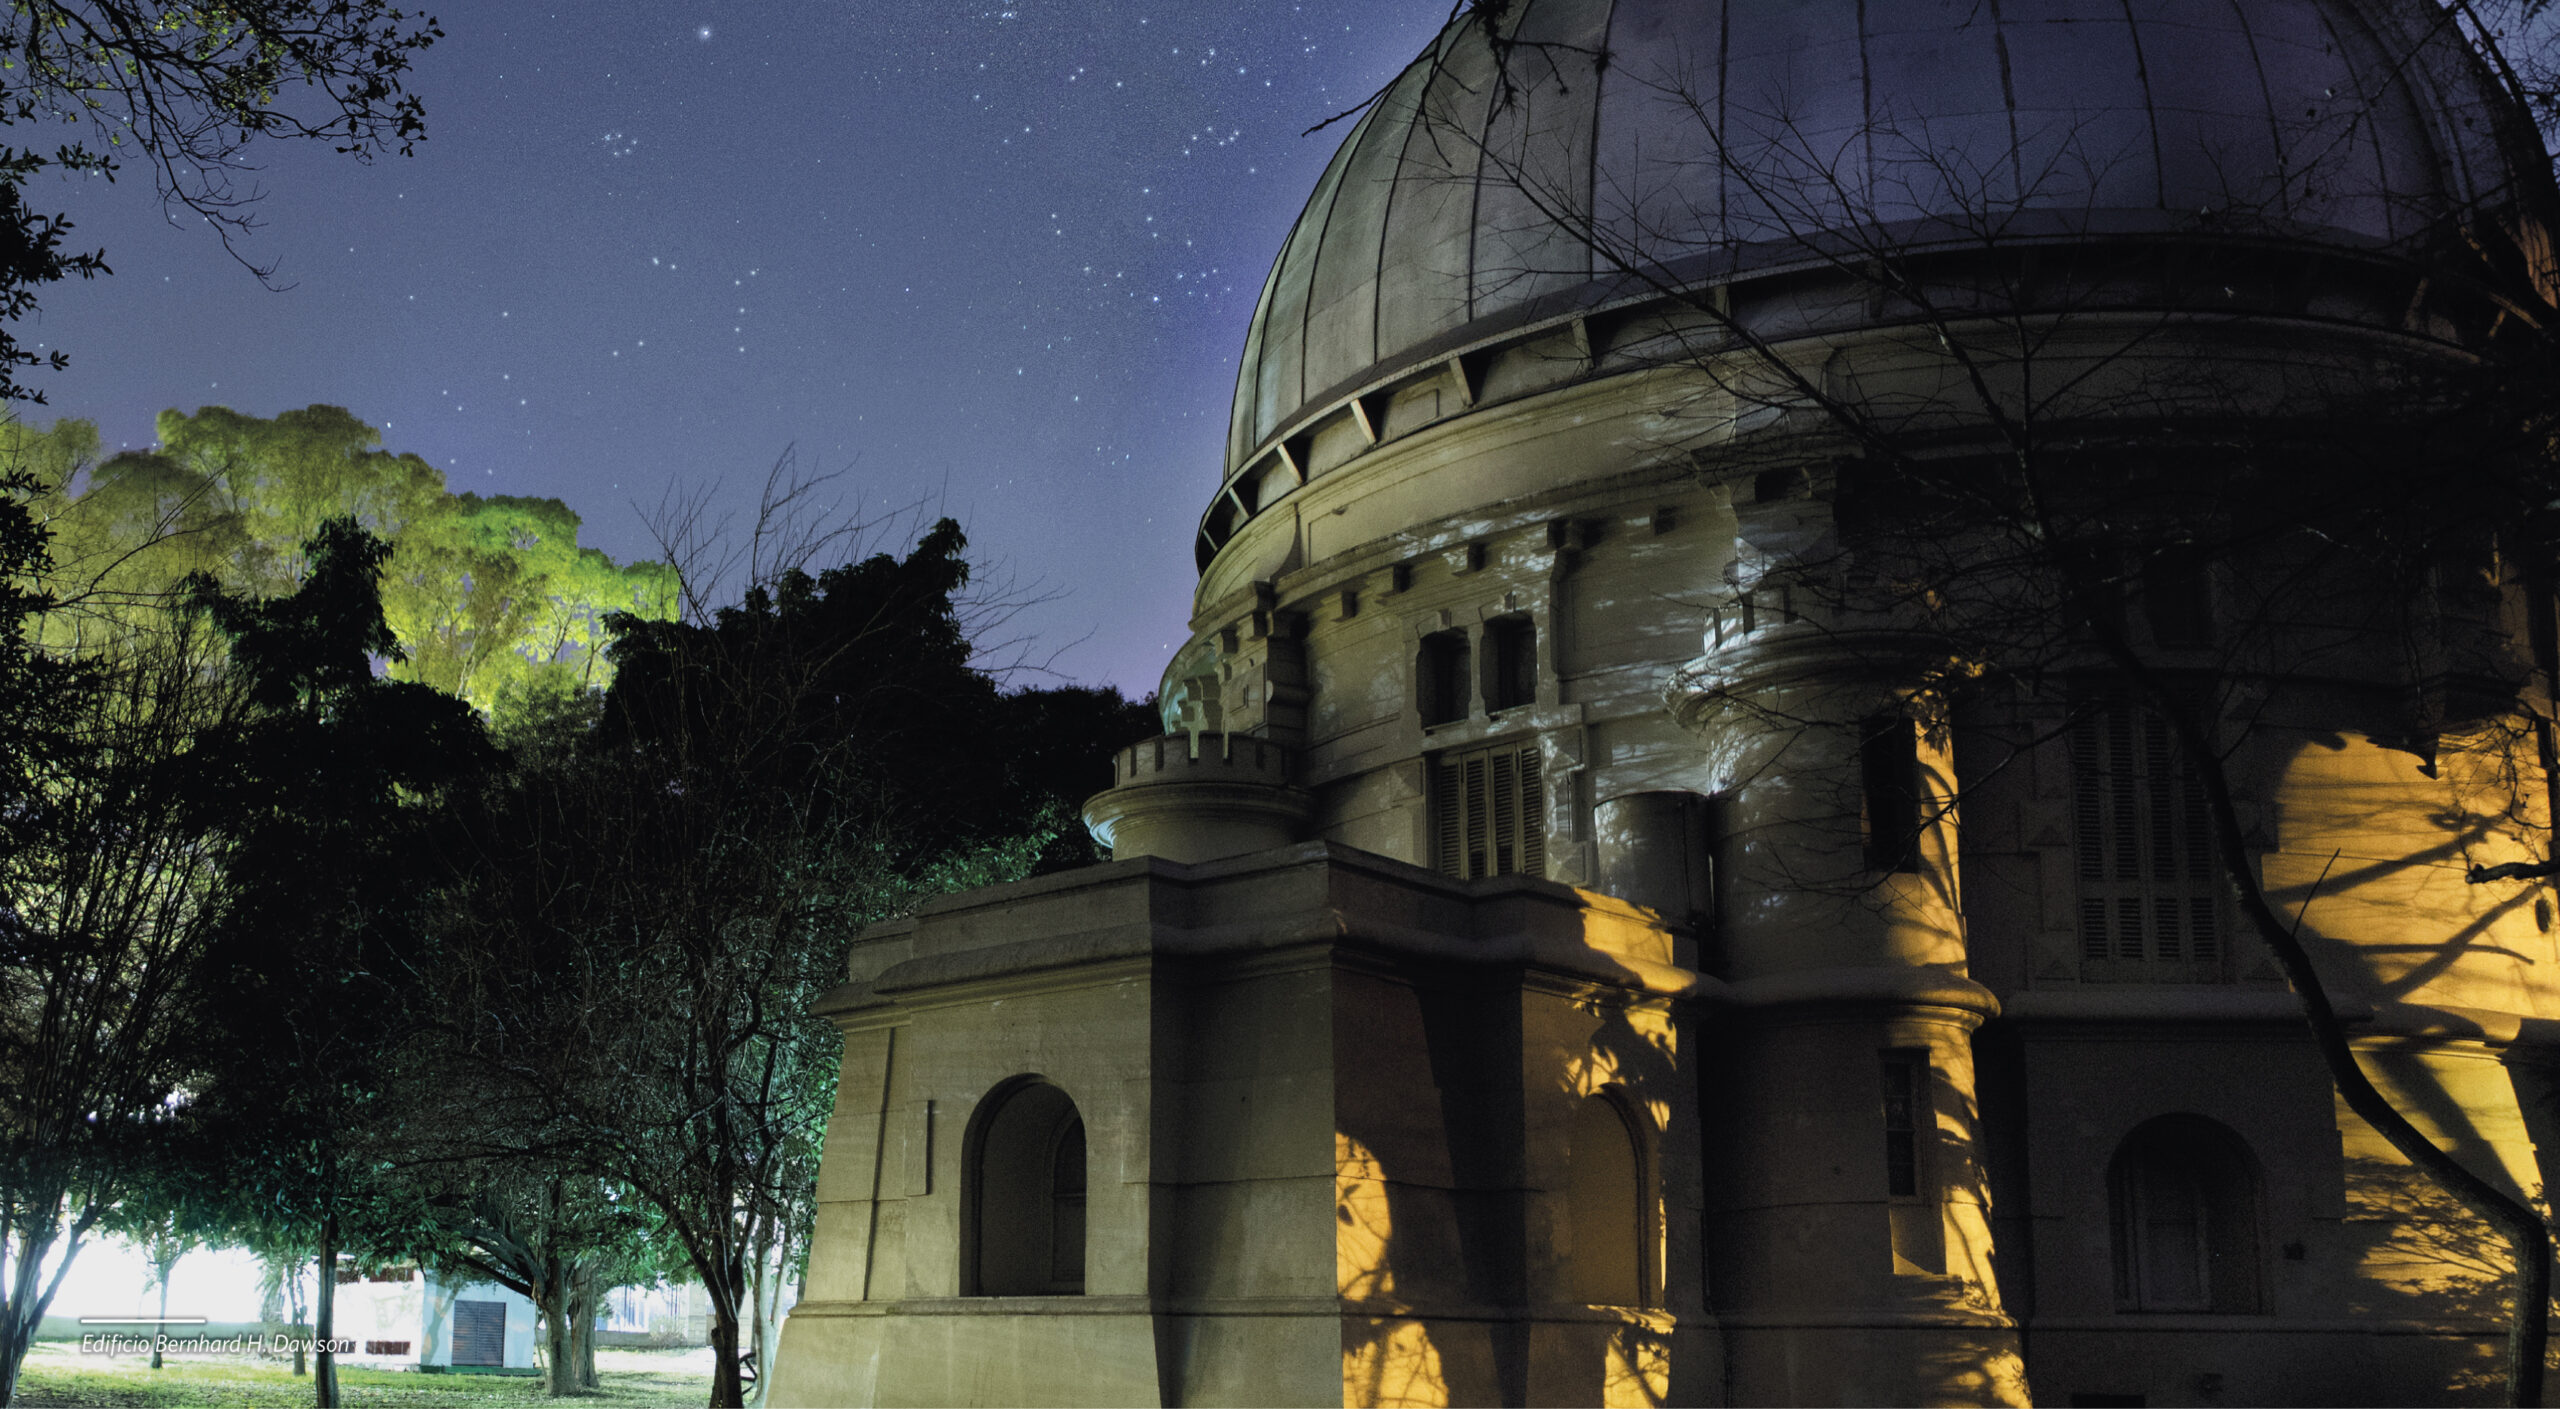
[1226,0,2532,471]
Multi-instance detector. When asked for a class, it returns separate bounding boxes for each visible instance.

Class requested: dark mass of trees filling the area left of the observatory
[0,456,1152,1404]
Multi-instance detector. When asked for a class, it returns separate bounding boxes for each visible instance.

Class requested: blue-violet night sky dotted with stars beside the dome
[20,0,1449,694]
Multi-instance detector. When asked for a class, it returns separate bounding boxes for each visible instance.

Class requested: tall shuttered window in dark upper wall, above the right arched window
[2071,699,2222,984]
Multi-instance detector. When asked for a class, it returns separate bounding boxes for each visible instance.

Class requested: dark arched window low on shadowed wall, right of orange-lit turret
[2107,1114,2260,1312]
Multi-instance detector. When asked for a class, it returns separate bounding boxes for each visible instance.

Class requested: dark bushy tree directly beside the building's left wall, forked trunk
[417,520,1144,1404]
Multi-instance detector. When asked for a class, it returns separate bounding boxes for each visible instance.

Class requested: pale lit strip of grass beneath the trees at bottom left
[18,1340,712,1409]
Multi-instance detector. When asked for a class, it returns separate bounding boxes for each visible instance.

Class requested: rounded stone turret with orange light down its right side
[1669,630,2025,1404]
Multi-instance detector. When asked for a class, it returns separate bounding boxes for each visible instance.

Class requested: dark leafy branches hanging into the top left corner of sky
[0,0,443,402]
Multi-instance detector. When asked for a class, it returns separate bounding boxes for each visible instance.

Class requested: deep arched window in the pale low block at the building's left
[960,1081,1085,1296]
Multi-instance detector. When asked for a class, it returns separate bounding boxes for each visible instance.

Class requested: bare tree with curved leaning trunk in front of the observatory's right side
[1341,3,2560,1404]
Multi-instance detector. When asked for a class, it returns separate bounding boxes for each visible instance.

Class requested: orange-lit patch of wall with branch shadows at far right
[2263,722,2560,1396]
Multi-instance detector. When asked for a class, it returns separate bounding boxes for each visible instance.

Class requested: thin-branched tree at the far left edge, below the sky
[0,479,241,1404]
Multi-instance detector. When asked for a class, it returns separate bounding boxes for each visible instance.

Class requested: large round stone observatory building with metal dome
[776,0,2560,1404]
